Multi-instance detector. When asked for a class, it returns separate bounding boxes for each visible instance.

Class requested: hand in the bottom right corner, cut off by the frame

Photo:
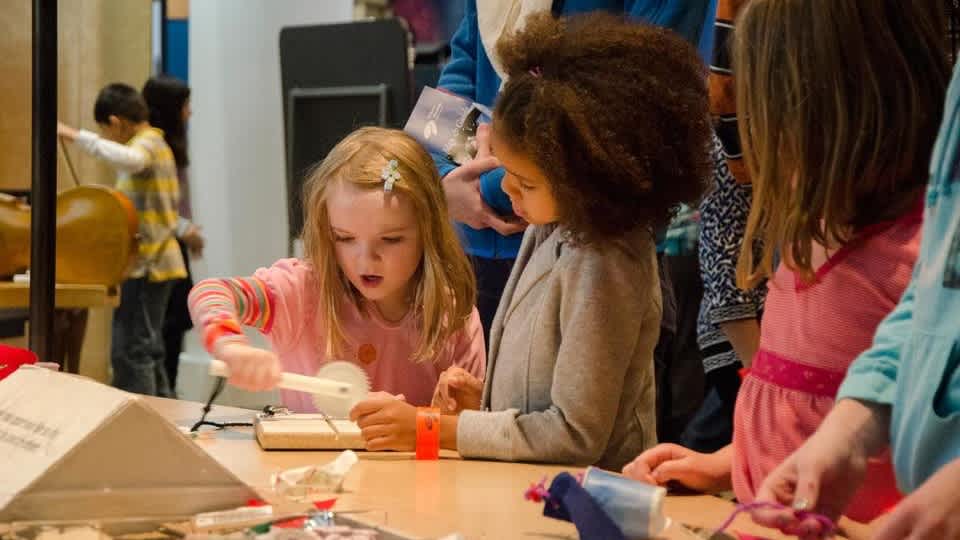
[874,459,960,540]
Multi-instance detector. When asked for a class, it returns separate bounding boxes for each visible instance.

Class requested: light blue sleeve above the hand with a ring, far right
[837,261,921,405]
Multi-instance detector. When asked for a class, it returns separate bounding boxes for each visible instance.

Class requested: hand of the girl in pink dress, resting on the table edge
[623,444,731,493]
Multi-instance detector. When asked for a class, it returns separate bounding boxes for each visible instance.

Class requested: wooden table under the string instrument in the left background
[0,281,120,373]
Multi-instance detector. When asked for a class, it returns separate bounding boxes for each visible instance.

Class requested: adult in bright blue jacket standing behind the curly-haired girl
[434,0,716,337]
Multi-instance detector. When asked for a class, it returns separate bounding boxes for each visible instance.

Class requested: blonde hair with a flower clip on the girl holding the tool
[303,127,477,362]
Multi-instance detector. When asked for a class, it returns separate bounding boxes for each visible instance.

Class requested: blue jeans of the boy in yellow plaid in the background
[110,278,173,397]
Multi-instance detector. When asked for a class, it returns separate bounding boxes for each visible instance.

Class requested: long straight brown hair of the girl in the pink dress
[734,0,949,287]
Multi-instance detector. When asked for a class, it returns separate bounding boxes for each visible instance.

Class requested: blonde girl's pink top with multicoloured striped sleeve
[189,259,486,412]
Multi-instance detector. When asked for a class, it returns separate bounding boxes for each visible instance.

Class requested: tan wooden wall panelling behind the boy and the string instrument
[0,0,151,190]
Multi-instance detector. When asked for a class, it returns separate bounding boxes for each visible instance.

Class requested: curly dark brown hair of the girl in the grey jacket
[494,12,712,242]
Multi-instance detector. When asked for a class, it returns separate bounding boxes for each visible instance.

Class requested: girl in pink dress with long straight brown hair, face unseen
[624,0,948,522]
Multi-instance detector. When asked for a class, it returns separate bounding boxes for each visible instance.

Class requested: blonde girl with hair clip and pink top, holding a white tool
[190,128,485,412]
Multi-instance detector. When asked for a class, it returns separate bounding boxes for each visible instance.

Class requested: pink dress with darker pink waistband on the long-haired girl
[732,211,922,522]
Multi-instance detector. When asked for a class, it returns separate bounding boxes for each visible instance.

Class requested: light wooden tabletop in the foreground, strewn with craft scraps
[145,398,783,540]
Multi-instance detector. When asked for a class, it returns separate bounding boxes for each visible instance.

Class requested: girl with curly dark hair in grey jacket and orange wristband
[351,13,712,468]
